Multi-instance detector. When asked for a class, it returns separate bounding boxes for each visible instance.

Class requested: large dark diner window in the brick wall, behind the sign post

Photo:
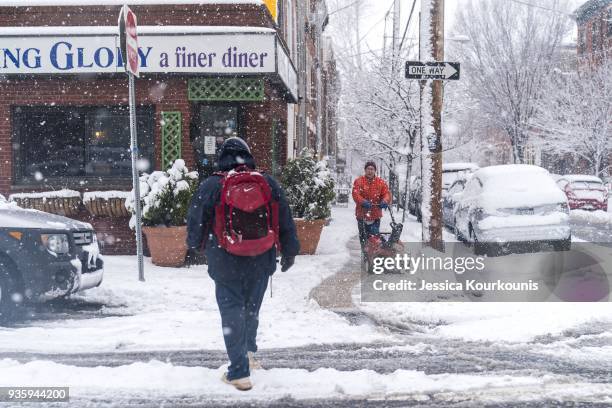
[13,106,155,184]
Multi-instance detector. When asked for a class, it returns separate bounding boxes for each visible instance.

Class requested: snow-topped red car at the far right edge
[557,174,608,211]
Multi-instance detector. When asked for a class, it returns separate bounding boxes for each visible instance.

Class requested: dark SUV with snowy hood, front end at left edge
[0,195,104,322]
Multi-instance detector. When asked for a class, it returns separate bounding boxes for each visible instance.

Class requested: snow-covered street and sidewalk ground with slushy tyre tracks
[0,208,612,406]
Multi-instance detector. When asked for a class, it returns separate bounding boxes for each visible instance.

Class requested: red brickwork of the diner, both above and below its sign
[0,4,287,254]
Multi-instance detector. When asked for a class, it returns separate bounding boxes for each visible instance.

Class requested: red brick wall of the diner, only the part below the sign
[0,76,287,254]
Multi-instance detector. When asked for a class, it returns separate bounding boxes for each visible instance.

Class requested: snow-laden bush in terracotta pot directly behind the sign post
[125,159,198,228]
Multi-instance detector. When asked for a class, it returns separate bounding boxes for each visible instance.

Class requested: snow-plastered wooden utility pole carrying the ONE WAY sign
[419,0,444,250]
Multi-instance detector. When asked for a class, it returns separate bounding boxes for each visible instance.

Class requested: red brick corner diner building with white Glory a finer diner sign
[0,0,340,253]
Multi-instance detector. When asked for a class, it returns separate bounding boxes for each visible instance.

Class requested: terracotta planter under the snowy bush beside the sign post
[142,226,187,267]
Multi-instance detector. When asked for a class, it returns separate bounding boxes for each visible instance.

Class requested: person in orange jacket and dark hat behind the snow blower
[353,161,391,250]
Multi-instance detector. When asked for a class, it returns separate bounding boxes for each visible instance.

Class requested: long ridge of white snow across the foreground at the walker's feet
[0,359,584,400]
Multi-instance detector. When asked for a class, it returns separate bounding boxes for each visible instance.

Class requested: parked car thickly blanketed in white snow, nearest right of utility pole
[455,164,571,254]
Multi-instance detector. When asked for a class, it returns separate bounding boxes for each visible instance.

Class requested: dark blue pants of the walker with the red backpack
[215,271,269,380]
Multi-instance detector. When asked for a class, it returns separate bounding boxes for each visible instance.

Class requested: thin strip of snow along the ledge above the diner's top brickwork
[0,0,263,7]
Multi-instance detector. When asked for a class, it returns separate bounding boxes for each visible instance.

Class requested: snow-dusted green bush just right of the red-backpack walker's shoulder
[281,150,336,220]
